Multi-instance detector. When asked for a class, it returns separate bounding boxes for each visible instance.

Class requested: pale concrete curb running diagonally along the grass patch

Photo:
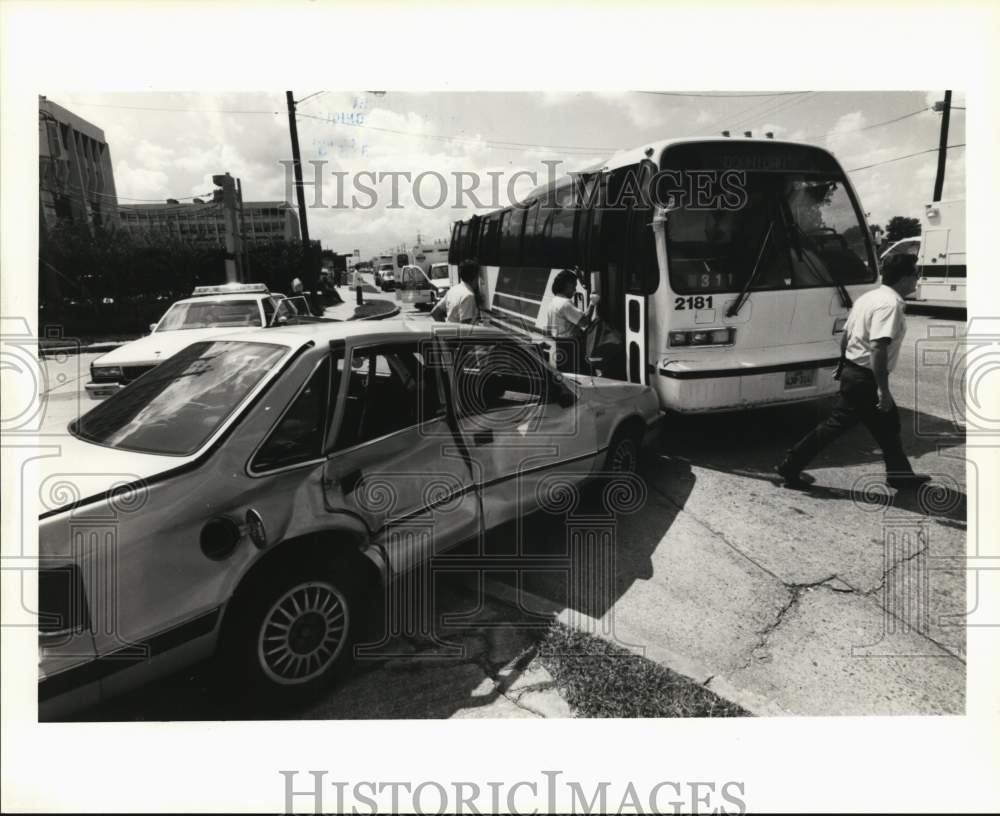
[468,577,791,717]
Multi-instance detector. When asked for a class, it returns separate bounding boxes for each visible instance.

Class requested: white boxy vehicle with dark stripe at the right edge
[914,199,965,309]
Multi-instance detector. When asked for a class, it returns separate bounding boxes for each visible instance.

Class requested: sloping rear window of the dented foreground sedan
[70,341,287,456]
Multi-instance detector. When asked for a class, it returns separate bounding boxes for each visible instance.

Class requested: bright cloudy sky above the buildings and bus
[47,88,965,257]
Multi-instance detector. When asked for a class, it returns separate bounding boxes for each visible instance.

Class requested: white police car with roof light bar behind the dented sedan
[85,283,291,399]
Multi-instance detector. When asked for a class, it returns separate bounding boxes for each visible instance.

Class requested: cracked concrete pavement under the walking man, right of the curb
[500,317,967,715]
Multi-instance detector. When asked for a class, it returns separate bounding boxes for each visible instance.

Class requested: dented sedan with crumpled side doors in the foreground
[39,320,660,718]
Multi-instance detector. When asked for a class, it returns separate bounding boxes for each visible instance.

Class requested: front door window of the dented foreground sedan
[450,339,555,416]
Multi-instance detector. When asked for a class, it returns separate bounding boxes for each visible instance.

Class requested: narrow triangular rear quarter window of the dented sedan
[250,355,342,473]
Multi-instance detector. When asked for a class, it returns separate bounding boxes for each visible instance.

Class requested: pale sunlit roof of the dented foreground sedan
[216,318,520,348]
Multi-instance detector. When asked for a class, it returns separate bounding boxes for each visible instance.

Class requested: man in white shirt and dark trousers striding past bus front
[775,255,930,489]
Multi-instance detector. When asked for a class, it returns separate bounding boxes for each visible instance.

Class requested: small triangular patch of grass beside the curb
[538,623,752,717]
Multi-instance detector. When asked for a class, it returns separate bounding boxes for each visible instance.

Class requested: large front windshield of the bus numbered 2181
[667,171,875,293]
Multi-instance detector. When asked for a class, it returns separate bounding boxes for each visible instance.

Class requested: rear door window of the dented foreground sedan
[336,343,445,450]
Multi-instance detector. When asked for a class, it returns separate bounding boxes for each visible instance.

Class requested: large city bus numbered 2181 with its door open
[449,138,878,413]
